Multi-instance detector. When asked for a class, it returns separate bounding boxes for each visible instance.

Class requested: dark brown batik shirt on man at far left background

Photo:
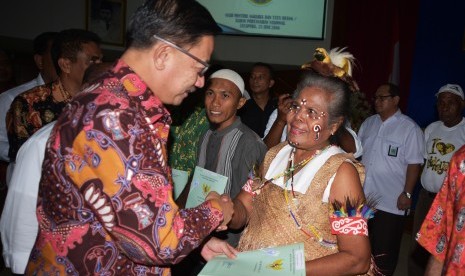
[6,80,67,161]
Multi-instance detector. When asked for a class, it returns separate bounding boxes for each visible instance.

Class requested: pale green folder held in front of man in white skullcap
[186,166,228,208]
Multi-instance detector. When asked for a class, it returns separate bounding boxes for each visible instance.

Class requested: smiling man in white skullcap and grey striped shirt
[197,69,267,246]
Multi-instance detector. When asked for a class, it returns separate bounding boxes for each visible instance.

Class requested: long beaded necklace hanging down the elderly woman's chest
[283,145,337,249]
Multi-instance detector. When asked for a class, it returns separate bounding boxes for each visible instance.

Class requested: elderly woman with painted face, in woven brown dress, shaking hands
[225,48,373,275]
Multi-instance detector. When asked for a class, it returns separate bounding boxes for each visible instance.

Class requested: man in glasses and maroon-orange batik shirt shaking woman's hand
[26,0,233,275]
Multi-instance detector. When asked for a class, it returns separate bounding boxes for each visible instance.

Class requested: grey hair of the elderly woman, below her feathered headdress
[293,70,350,125]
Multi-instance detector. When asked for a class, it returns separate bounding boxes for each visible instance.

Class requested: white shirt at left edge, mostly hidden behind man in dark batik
[0,74,44,162]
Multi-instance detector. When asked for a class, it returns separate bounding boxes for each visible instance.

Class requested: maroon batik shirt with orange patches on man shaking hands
[26,60,223,275]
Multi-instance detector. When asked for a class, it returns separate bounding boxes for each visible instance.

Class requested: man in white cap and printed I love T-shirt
[408,84,465,275]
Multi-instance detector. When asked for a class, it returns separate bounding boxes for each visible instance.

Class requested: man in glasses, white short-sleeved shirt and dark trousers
[358,83,425,275]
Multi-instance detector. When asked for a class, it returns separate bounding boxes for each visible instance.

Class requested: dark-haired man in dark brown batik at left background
[6,29,102,162]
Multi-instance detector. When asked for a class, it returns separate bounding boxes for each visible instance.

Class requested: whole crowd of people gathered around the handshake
[0,0,465,275]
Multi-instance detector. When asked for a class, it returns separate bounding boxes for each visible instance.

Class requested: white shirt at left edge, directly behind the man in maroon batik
[0,122,55,274]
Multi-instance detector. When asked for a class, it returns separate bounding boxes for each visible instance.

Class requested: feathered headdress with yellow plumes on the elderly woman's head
[301,47,359,92]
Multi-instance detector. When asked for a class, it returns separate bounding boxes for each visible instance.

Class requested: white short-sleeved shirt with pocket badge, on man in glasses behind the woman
[358,110,425,215]
